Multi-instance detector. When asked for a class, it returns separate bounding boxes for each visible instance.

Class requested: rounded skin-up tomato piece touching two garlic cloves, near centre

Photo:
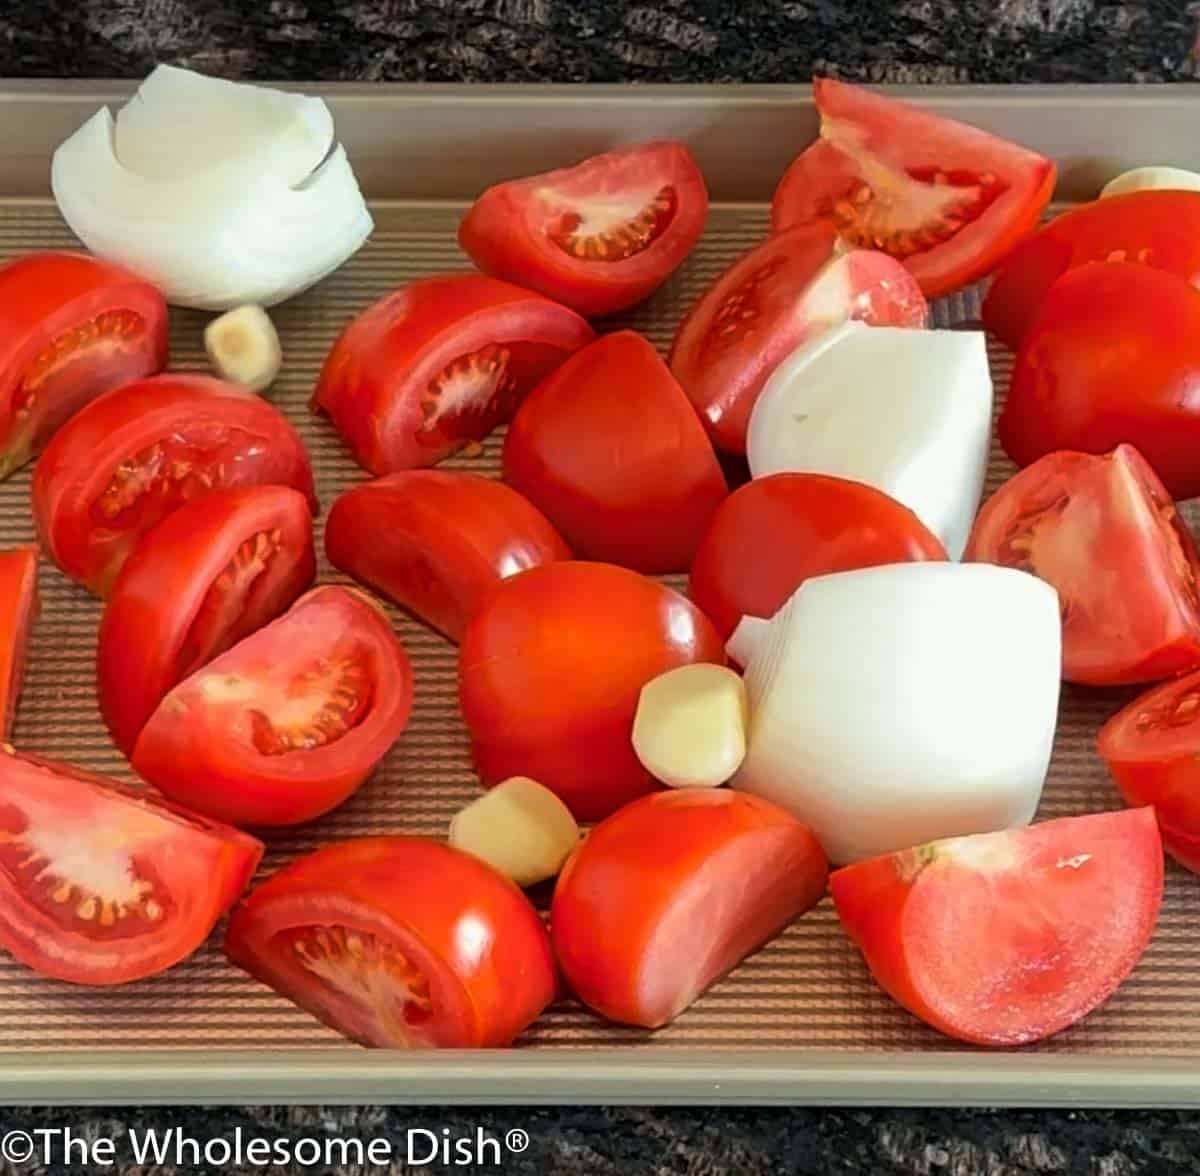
[458,562,725,821]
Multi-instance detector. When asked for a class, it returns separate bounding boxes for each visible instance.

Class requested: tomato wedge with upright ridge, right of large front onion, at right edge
[965,445,1200,685]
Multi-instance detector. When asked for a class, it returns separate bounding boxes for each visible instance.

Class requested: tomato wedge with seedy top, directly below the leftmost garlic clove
[32,376,317,596]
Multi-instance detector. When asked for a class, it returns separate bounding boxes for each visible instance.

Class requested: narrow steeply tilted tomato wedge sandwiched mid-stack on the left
[96,486,317,755]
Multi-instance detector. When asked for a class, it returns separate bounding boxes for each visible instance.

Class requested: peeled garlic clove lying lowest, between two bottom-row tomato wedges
[449,776,580,886]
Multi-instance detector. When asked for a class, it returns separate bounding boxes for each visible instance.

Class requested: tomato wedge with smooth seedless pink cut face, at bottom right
[829,809,1163,1045]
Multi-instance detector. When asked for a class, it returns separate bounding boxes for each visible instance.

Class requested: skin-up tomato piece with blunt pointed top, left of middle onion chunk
[504,331,727,572]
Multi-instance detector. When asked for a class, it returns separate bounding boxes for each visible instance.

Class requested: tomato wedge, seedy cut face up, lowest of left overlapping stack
[131,587,413,826]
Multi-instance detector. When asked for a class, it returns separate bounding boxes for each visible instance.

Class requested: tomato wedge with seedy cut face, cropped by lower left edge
[0,745,263,984]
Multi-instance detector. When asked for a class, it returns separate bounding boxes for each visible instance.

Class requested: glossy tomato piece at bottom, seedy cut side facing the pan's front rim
[226,836,556,1049]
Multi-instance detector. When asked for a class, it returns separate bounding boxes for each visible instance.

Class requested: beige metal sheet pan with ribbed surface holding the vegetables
[0,83,1200,1105]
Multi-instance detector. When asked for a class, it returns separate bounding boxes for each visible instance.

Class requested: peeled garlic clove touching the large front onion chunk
[634,664,746,788]
